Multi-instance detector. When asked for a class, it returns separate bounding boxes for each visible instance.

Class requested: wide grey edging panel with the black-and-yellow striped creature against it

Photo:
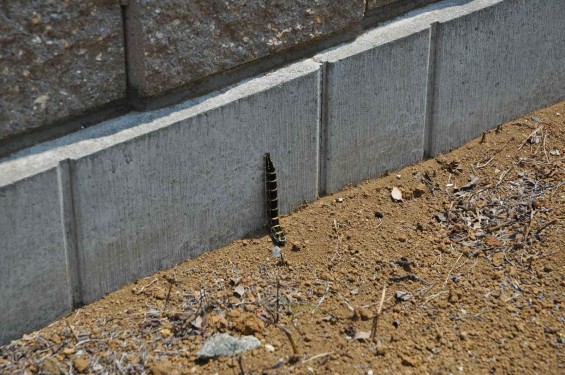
[72,61,320,303]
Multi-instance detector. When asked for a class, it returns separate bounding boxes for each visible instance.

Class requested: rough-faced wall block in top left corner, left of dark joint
[0,0,126,139]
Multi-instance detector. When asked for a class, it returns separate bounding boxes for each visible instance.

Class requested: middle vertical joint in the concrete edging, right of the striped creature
[318,61,328,196]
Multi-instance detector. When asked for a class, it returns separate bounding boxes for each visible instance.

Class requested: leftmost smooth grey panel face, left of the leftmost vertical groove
[0,168,71,344]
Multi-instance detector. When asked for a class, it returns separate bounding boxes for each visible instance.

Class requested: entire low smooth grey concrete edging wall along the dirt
[0,0,565,342]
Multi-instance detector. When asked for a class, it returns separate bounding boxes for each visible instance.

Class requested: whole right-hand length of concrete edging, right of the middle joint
[316,0,565,193]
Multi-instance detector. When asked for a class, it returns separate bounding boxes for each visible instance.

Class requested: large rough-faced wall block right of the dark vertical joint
[127,0,365,97]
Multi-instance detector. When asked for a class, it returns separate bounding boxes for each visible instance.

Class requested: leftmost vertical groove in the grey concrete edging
[57,159,83,309]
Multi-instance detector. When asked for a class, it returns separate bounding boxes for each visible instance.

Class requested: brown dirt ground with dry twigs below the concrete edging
[0,102,565,375]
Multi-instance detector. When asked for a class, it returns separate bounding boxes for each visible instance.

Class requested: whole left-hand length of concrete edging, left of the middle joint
[0,61,320,343]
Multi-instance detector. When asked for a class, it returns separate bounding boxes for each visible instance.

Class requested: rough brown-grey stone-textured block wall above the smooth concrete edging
[0,0,437,156]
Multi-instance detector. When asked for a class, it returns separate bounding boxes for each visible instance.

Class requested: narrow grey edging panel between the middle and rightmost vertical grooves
[318,23,429,193]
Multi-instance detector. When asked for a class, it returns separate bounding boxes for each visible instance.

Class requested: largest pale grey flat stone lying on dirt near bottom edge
[198,333,261,358]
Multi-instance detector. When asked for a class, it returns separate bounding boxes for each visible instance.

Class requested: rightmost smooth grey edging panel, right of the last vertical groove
[428,0,565,155]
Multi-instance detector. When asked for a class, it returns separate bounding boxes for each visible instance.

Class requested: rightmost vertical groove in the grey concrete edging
[423,22,439,159]
